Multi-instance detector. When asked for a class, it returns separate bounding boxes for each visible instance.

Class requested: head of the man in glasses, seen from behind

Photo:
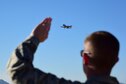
[82,31,119,78]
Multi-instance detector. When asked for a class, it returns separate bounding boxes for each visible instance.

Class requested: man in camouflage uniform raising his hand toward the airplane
[7,17,119,84]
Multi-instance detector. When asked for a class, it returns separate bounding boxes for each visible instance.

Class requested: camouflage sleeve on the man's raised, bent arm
[7,37,80,84]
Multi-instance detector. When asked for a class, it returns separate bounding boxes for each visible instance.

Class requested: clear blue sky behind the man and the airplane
[0,0,126,83]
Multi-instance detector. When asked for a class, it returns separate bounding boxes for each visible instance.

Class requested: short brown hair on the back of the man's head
[85,31,119,68]
